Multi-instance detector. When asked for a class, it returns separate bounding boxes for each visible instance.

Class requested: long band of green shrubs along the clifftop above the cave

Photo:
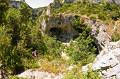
[53,2,120,21]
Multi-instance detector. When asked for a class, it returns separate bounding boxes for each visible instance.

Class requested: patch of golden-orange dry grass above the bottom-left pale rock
[39,59,67,74]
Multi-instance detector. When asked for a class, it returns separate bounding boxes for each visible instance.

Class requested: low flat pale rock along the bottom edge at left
[17,69,63,79]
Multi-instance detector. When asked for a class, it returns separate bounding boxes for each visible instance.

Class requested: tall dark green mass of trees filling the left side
[0,0,41,74]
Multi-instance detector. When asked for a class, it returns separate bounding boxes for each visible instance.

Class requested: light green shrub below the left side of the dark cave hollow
[43,35,61,60]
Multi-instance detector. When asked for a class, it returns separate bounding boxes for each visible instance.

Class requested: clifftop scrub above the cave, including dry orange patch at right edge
[52,2,120,41]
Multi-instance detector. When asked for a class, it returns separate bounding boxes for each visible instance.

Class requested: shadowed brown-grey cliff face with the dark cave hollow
[41,15,78,42]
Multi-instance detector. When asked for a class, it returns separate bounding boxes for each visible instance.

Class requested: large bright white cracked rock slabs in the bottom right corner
[83,41,120,79]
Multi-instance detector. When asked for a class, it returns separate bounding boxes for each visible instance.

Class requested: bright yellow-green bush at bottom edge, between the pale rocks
[63,67,101,79]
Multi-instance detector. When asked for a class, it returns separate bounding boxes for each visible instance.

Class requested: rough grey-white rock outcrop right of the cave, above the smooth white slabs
[84,19,111,51]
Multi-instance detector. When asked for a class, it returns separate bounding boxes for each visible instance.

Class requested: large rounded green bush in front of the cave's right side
[66,25,97,65]
